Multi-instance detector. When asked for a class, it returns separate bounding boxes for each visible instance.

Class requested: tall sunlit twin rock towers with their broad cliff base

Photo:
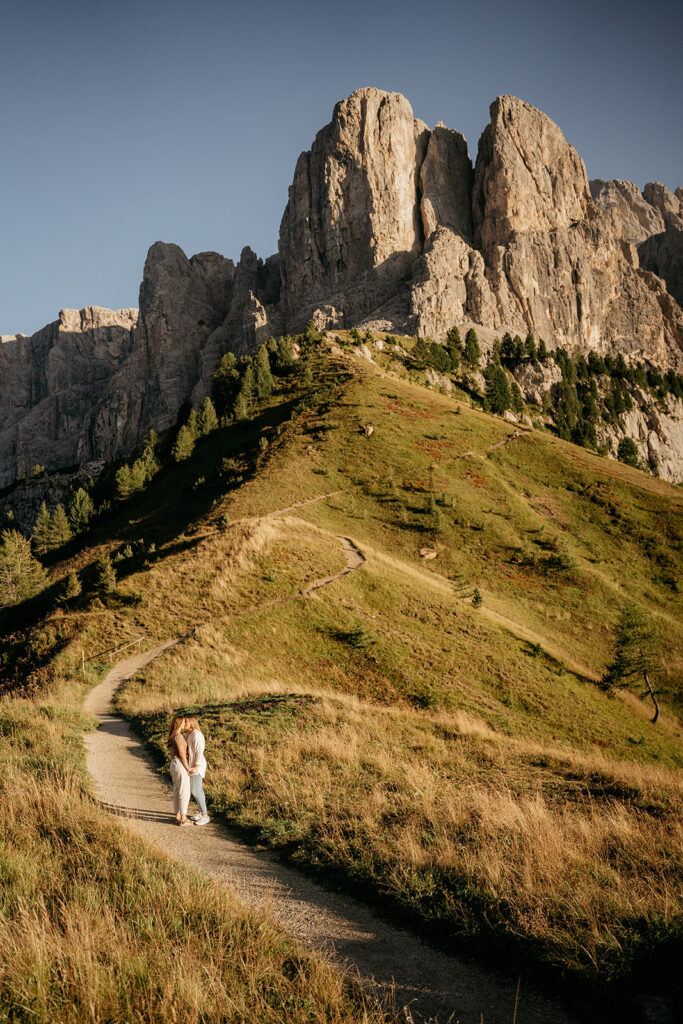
[280,89,683,367]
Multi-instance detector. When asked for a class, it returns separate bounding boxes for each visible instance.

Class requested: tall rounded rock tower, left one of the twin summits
[280,89,429,330]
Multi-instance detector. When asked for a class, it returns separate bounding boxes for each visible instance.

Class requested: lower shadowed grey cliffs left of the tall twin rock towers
[0,242,279,486]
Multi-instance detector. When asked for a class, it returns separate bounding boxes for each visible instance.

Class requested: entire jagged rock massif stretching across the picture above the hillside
[0,88,683,485]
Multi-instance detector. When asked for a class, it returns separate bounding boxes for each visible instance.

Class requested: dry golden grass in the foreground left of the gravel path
[0,687,384,1024]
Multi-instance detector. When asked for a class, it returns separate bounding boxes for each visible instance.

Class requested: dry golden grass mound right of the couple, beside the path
[123,669,683,977]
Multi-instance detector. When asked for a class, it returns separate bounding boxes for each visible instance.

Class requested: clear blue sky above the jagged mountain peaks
[0,0,683,334]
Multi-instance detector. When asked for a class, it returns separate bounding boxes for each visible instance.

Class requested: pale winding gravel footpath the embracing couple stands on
[85,528,571,1024]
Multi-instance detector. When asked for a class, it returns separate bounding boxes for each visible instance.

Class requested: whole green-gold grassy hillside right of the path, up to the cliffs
[5,335,683,1015]
